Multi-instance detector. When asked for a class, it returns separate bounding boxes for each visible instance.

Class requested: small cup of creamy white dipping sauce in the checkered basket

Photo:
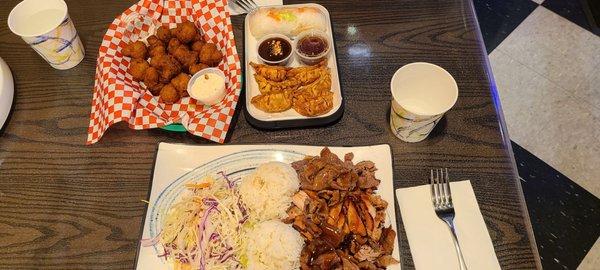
[189,73,225,105]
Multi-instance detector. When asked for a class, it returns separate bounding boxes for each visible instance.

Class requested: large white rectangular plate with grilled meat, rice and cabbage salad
[136,143,400,269]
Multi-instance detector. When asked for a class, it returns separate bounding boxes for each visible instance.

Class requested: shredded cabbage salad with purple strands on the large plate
[146,172,248,270]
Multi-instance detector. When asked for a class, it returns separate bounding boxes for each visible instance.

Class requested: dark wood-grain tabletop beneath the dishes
[0,0,539,269]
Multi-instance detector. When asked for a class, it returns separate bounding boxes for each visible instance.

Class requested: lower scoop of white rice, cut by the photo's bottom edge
[246,220,304,270]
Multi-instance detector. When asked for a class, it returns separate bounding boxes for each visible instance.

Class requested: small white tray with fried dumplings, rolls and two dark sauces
[244,4,343,129]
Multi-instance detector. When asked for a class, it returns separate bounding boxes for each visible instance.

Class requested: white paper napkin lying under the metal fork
[396,181,500,270]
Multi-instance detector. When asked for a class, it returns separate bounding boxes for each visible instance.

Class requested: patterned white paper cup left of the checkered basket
[8,0,84,69]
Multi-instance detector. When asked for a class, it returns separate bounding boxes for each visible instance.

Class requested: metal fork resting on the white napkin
[430,168,467,270]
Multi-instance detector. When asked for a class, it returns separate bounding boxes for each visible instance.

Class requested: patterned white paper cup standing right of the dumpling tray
[390,62,458,142]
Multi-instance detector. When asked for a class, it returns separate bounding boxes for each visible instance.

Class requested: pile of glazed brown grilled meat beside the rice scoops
[284,148,399,270]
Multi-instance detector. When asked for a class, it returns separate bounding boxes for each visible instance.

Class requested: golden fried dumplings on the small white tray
[250,61,333,117]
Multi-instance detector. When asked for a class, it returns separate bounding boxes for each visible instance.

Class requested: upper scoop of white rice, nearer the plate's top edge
[239,162,299,221]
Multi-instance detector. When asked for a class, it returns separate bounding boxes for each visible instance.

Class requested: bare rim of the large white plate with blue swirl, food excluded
[136,143,400,270]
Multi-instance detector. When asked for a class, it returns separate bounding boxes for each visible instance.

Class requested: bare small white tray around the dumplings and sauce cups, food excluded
[244,3,343,128]
